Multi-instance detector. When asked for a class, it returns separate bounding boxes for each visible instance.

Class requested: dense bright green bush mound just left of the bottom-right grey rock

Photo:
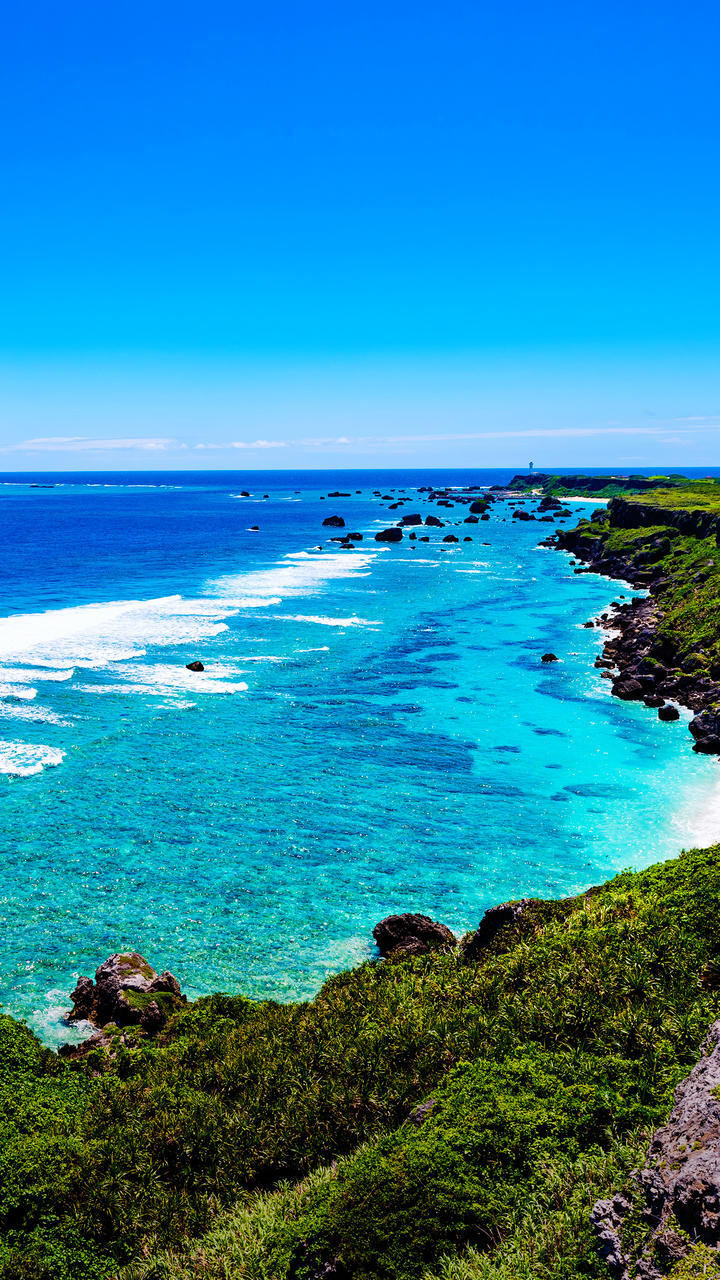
[270,1051,657,1280]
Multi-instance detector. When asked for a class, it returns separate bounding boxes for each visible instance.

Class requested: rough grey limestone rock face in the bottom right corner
[592,1021,720,1280]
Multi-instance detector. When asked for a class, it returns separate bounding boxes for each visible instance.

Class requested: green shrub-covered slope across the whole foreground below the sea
[0,847,720,1280]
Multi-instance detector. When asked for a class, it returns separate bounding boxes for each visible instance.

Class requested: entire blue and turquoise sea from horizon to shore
[0,474,720,1043]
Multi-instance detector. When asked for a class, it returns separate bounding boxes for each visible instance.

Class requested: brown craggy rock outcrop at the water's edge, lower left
[69,951,183,1027]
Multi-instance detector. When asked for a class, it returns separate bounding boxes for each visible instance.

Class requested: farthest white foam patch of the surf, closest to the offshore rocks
[208,552,375,604]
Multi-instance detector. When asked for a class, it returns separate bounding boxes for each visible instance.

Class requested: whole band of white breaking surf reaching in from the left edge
[0,550,377,777]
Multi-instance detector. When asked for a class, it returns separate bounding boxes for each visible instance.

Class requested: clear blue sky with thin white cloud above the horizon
[0,0,720,470]
